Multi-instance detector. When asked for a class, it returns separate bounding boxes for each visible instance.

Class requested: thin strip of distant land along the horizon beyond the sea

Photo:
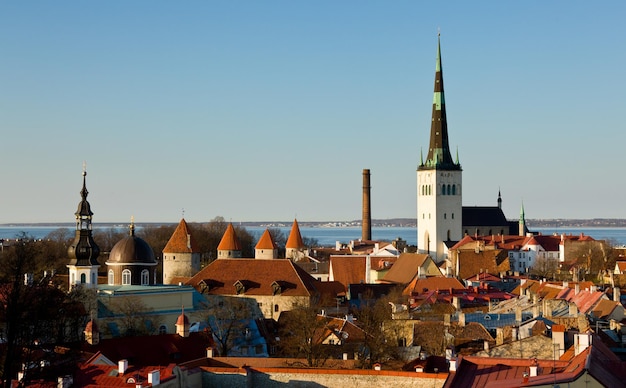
[0,218,626,229]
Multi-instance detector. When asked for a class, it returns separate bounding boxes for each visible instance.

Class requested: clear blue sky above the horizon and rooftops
[0,1,626,223]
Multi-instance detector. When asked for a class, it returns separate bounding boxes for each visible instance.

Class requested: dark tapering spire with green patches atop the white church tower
[420,34,461,170]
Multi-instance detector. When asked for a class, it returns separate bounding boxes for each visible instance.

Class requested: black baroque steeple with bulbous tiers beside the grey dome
[67,166,100,266]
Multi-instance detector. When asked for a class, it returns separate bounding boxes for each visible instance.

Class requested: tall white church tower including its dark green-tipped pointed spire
[417,37,463,262]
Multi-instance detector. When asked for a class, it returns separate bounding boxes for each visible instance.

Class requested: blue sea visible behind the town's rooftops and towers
[0,225,626,246]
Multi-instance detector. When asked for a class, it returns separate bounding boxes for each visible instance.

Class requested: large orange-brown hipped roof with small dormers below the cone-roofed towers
[186,259,319,296]
